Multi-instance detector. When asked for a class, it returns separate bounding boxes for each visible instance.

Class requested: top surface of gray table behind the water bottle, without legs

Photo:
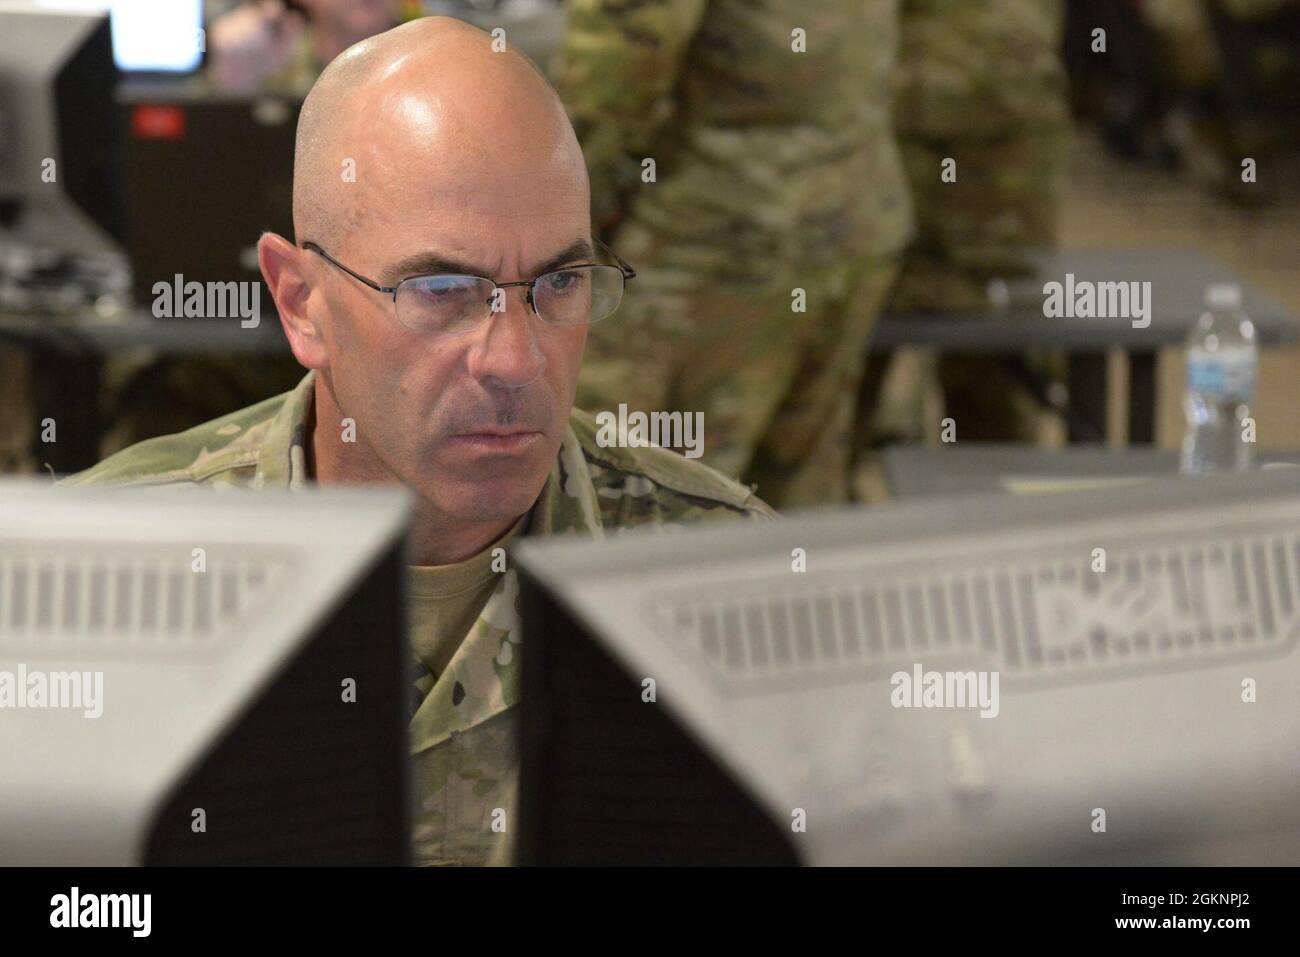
[872,250,1300,352]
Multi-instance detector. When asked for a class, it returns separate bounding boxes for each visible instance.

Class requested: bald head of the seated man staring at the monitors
[260,17,590,546]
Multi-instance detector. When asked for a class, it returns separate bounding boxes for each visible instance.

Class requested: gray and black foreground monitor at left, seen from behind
[0,481,410,866]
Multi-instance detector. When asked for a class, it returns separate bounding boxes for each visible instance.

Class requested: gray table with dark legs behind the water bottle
[872,250,1297,443]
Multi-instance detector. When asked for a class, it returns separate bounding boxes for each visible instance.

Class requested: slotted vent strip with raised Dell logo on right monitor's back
[650,534,1300,689]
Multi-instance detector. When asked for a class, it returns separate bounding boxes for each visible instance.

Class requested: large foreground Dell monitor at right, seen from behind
[517,469,1300,865]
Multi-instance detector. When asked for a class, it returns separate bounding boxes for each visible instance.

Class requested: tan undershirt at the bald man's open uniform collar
[407,512,528,679]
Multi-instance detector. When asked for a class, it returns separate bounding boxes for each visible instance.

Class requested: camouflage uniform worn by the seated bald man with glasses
[64,373,772,865]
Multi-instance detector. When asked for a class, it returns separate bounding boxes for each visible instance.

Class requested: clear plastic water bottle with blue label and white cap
[1180,282,1260,475]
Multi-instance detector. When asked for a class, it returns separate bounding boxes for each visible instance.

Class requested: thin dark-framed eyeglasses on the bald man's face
[303,237,637,335]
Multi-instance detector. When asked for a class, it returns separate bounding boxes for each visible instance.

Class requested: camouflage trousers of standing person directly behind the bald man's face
[576,221,898,508]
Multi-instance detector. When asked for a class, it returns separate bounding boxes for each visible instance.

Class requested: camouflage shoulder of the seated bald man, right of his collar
[569,410,776,525]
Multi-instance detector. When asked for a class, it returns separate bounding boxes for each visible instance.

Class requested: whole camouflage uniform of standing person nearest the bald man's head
[558,0,913,506]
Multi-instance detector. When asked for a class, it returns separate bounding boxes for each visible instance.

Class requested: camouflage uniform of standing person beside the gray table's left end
[889,0,1069,441]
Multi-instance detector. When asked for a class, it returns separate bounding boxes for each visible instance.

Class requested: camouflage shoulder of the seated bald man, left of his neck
[59,395,283,486]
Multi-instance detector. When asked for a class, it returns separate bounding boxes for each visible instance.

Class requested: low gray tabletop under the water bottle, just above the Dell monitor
[884,442,1300,499]
